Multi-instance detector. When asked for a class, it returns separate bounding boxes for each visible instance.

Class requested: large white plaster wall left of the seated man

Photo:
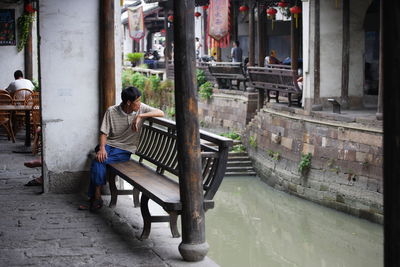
[40,0,100,191]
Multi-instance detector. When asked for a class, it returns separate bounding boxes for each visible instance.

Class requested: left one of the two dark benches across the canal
[208,62,248,90]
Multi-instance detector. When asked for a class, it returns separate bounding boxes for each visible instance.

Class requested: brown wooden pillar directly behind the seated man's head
[100,0,115,117]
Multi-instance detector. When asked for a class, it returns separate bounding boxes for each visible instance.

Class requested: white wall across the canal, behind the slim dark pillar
[320,0,372,97]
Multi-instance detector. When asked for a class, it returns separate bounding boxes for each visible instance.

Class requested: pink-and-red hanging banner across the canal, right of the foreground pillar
[208,0,229,47]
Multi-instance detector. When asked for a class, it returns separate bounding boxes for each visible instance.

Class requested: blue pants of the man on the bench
[88,145,132,198]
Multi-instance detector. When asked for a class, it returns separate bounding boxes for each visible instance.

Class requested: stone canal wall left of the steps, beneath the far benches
[198,89,258,132]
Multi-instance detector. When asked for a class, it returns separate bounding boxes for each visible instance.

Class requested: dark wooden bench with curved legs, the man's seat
[107,118,232,239]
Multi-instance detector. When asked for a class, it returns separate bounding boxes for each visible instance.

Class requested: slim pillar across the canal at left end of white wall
[314,0,321,106]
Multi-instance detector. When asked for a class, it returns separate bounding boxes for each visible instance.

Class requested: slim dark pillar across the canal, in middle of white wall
[340,0,350,108]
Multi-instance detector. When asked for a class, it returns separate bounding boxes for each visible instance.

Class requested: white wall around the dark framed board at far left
[0,3,24,89]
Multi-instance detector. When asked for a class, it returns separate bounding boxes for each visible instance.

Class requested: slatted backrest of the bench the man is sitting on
[136,118,232,200]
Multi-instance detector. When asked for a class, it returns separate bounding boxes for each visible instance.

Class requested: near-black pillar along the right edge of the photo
[381,0,400,267]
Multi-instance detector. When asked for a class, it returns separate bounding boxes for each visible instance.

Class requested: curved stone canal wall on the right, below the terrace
[243,107,383,223]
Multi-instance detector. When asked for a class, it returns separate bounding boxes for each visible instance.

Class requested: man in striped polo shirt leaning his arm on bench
[79,87,164,211]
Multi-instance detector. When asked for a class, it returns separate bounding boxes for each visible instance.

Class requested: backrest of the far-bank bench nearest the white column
[247,67,301,92]
